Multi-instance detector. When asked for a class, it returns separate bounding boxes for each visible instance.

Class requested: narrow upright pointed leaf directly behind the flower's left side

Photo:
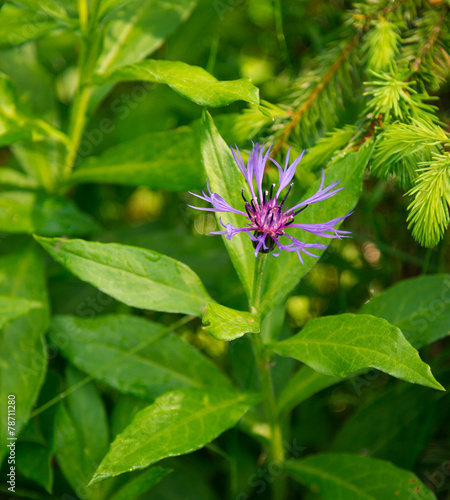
[201,112,255,297]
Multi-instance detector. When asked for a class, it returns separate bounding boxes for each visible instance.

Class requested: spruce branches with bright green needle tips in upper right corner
[250,0,450,247]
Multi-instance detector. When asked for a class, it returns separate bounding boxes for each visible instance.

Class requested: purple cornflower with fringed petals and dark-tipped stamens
[189,143,353,264]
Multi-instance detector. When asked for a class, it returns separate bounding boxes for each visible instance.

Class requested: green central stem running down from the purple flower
[250,254,286,500]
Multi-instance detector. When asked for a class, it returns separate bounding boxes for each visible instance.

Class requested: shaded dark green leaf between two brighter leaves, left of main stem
[50,315,230,399]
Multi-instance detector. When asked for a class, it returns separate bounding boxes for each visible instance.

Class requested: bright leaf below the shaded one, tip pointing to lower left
[91,387,259,483]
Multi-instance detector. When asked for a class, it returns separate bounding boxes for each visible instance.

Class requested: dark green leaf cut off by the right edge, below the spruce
[359,274,450,349]
